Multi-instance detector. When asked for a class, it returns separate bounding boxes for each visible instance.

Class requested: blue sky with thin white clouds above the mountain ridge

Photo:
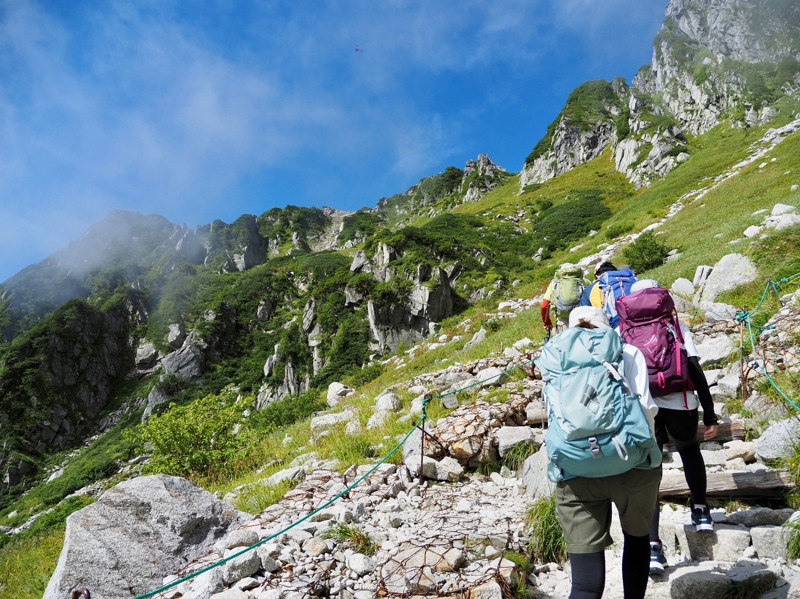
[0,0,666,282]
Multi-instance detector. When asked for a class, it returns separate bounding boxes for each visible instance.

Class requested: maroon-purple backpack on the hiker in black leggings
[617,287,694,397]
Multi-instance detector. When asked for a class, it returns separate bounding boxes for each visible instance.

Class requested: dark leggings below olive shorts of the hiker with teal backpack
[569,532,650,599]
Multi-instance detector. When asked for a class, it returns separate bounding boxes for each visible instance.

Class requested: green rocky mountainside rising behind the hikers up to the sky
[0,1,800,596]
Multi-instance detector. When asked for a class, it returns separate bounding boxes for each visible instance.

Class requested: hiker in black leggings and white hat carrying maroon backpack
[617,279,717,574]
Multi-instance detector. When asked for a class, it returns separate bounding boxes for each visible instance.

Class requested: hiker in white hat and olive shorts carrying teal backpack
[535,306,661,599]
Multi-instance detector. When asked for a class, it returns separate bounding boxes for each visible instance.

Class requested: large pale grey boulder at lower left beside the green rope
[44,475,250,599]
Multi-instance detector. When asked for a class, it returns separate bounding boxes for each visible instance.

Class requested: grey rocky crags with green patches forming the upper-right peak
[520,0,800,192]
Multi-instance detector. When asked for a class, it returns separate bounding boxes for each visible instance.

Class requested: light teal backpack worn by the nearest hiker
[535,328,661,482]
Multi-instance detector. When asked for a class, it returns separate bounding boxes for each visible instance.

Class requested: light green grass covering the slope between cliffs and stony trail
[0,111,800,597]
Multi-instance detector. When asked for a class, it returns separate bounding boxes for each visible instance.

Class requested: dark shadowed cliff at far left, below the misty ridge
[0,301,139,486]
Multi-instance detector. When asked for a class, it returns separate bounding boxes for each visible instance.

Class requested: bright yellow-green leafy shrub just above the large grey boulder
[138,391,251,476]
